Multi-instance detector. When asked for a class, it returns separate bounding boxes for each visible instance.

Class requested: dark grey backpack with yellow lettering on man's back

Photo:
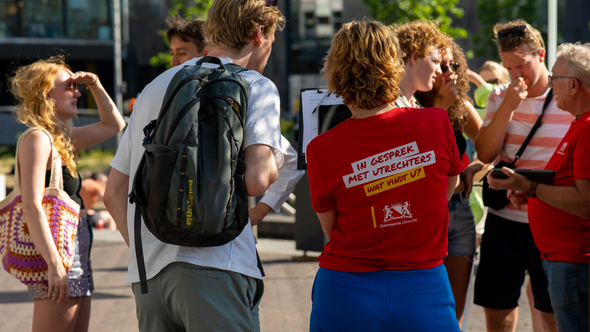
[129,57,253,293]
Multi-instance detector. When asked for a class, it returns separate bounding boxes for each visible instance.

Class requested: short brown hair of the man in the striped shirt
[494,20,545,54]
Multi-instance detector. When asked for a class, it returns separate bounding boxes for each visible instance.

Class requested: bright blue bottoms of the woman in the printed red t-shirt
[309,264,460,332]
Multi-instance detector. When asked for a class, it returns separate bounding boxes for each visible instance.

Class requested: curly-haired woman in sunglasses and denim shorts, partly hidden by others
[415,39,483,324]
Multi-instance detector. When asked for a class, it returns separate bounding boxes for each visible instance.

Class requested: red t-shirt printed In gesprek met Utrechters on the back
[306,108,461,272]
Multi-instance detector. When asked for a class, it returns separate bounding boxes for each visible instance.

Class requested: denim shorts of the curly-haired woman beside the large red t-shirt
[447,193,475,256]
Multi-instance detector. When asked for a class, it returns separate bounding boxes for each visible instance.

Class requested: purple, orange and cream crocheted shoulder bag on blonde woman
[0,128,80,285]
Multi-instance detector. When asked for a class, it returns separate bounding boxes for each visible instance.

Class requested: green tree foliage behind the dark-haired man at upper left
[150,0,213,69]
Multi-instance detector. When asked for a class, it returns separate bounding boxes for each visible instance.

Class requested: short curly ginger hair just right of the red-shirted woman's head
[394,20,447,63]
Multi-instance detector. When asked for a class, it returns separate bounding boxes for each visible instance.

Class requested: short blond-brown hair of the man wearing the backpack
[205,0,285,50]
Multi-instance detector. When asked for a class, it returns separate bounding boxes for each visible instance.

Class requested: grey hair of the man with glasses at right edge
[556,42,590,87]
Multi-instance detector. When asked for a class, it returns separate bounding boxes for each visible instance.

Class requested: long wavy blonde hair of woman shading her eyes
[8,56,78,177]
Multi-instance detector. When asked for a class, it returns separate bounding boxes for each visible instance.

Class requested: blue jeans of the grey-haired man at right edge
[543,260,588,332]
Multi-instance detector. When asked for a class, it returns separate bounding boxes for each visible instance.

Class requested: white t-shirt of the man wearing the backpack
[111,58,283,283]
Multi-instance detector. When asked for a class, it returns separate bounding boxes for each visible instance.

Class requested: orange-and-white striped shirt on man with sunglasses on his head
[482,84,574,223]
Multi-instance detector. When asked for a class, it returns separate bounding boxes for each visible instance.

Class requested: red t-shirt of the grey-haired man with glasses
[529,112,590,264]
